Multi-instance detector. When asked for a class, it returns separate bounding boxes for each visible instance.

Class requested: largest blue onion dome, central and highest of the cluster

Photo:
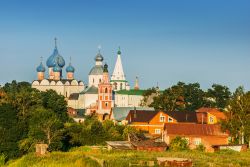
[46,47,65,68]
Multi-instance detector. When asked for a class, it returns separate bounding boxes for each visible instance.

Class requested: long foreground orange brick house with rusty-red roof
[164,123,229,152]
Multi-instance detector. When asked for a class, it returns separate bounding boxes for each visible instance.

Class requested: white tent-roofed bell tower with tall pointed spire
[110,47,130,91]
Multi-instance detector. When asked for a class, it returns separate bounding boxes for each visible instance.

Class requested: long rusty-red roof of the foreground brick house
[165,123,228,136]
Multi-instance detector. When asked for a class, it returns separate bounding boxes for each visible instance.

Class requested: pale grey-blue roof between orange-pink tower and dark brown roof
[112,107,154,121]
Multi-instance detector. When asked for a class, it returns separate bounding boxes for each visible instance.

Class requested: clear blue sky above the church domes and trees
[0,0,250,90]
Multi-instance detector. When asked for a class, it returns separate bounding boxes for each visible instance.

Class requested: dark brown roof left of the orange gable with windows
[127,110,158,122]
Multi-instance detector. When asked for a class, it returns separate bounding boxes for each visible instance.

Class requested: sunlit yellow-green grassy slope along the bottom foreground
[7,147,250,167]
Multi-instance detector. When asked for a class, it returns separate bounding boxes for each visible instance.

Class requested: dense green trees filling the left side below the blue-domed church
[0,81,131,162]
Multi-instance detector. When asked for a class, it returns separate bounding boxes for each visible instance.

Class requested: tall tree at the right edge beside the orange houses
[222,87,250,144]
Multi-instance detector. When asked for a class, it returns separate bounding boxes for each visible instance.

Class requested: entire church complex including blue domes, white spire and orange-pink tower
[32,39,144,120]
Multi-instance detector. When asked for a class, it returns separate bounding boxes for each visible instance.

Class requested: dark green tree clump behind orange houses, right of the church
[142,82,231,111]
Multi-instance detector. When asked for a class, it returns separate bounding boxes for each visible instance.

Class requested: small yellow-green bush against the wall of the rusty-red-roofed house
[170,136,188,151]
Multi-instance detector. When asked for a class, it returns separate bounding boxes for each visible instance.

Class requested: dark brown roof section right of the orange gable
[164,111,197,123]
